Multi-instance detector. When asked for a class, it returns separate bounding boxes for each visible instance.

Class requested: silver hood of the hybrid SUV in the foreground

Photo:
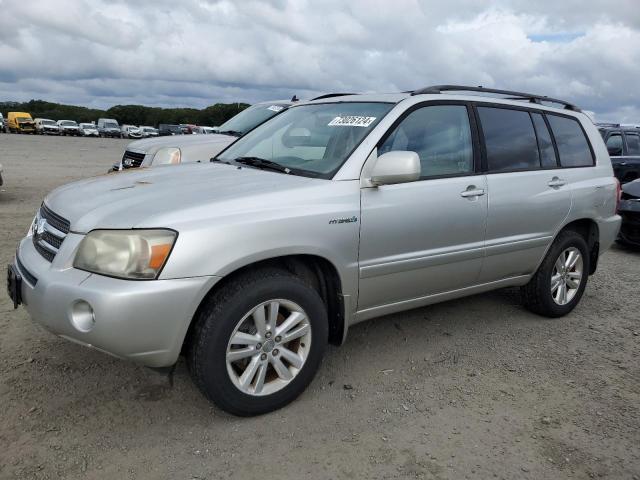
[44,163,318,233]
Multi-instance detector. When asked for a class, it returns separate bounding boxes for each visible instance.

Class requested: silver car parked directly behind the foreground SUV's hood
[112,100,292,171]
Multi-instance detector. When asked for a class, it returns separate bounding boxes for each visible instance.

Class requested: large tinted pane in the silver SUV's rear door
[478,107,540,172]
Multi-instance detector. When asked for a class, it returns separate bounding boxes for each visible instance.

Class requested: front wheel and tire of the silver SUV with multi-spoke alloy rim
[187,269,328,416]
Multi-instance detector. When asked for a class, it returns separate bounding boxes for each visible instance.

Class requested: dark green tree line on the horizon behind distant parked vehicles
[0,100,249,127]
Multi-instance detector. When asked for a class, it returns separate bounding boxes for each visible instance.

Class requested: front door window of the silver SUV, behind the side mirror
[378,105,473,178]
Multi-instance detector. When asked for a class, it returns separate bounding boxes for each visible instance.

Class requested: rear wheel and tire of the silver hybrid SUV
[521,230,590,318]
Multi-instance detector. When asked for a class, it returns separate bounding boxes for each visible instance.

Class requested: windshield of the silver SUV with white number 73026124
[216,102,393,178]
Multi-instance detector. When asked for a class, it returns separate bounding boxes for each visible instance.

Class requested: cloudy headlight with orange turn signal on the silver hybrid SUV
[73,230,178,280]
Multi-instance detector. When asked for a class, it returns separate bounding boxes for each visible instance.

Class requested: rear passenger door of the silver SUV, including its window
[476,104,571,283]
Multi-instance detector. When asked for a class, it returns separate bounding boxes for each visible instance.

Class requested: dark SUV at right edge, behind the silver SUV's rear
[597,123,640,183]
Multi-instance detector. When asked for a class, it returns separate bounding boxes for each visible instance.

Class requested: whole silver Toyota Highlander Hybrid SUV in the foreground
[8,86,620,415]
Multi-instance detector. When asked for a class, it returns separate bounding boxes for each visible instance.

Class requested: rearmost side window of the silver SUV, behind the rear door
[547,115,593,167]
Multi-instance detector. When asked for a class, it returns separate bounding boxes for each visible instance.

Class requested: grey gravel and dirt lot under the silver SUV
[0,134,640,479]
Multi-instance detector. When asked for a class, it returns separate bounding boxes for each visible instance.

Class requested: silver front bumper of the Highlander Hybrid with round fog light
[14,233,218,367]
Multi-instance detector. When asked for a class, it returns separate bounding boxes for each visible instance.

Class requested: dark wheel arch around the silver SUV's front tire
[182,254,347,353]
